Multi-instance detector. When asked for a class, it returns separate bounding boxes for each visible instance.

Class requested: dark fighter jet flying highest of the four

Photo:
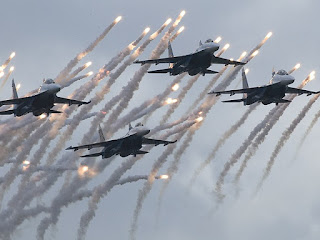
[134,39,245,76]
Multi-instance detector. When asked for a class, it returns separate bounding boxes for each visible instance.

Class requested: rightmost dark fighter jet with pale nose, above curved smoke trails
[209,69,319,105]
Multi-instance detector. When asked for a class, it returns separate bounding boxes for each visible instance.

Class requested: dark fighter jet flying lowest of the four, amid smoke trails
[66,123,176,158]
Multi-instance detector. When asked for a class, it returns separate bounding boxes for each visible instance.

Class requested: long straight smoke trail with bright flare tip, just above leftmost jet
[55,17,121,83]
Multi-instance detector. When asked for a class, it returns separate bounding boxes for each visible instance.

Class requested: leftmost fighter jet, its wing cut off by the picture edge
[0,79,90,117]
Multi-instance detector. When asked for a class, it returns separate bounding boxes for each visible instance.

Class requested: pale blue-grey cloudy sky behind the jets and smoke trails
[0,0,320,240]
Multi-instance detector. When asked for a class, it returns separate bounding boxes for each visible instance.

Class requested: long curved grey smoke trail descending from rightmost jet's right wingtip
[256,94,320,192]
